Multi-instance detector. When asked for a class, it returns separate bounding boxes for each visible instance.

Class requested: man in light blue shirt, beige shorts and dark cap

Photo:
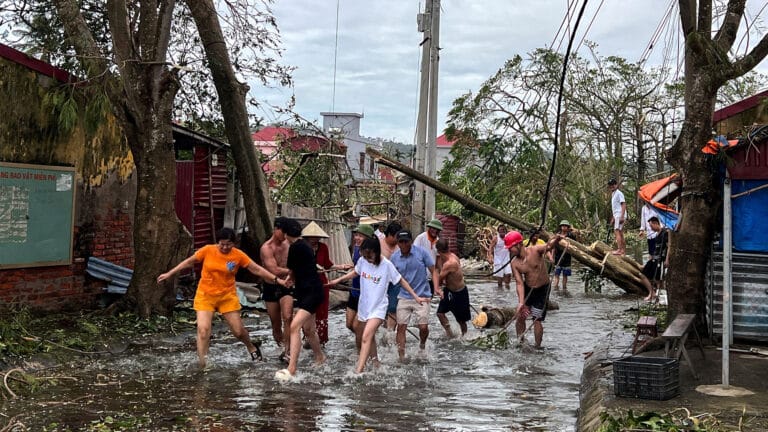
[390,230,443,361]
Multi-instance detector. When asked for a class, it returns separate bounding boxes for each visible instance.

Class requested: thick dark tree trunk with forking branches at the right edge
[667,0,768,313]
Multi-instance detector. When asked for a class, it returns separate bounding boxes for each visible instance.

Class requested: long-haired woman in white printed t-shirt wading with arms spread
[330,239,430,373]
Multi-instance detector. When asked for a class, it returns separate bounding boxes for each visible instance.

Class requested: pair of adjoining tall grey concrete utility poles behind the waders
[411,0,440,235]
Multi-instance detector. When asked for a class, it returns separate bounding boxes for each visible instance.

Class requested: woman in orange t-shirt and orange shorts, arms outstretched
[157,228,287,367]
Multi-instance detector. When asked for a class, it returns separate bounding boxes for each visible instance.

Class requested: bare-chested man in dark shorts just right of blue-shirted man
[435,238,472,338]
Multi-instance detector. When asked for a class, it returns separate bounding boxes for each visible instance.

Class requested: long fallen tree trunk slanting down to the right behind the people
[365,147,647,295]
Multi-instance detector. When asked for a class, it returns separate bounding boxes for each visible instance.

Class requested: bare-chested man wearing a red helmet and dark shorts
[504,231,563,348]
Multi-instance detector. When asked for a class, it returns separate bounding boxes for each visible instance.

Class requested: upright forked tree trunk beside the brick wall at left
[54,0,188,317]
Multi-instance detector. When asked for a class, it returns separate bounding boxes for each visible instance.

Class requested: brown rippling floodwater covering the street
[0,277,637,432]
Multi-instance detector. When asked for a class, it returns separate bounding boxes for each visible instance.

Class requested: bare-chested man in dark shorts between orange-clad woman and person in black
[259,217,293,361]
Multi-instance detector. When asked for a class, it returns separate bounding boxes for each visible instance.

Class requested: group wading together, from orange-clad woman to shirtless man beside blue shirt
[157,217,471,378]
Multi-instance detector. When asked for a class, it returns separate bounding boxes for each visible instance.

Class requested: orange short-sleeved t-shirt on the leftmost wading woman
[195,245,251,295]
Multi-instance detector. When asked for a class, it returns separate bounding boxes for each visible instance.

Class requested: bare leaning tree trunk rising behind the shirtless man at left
[187,0,274,245]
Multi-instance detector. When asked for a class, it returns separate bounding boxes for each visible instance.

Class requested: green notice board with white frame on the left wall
[0,162,75,269]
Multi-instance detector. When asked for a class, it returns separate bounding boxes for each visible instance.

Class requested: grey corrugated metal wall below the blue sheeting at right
[707,252,768,341]
